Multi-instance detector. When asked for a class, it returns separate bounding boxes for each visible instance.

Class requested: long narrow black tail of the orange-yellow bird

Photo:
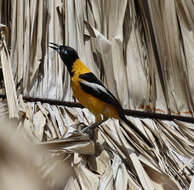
[119,114,153,148]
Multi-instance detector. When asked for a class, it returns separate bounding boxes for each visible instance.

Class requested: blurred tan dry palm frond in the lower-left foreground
[0,113,74,190]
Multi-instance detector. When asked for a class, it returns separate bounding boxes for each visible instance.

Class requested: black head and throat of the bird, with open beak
[49,43,79,74]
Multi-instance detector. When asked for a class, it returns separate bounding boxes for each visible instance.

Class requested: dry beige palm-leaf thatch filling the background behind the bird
[0,0,194,190]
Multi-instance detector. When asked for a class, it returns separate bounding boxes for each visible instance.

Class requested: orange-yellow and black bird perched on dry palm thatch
[49,42,153,147]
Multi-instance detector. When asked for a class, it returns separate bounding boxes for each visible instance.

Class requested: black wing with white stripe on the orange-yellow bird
[79,72,122,109]
